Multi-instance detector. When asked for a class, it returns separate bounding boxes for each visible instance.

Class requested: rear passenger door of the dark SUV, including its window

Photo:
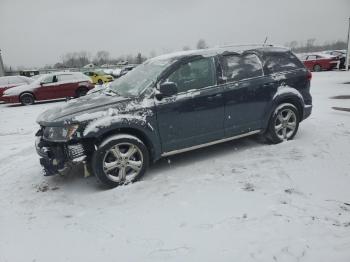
[220,53,270,137]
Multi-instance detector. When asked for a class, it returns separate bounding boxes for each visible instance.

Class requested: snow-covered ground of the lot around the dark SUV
[0,72,350,262]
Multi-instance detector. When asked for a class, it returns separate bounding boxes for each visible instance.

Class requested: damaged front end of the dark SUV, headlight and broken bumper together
[35,127,93,176]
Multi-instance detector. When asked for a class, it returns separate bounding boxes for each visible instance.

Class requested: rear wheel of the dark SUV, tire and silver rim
[265,103,300,144]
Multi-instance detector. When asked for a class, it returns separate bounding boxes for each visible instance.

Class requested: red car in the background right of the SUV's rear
[301,54,339,72]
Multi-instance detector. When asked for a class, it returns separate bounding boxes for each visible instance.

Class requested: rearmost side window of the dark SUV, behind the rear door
[265,52,302,73]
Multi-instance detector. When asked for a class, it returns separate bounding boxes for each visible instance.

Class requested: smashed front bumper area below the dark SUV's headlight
[35,137,86,176]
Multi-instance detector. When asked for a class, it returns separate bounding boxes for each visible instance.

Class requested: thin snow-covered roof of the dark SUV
[151,45,290,60]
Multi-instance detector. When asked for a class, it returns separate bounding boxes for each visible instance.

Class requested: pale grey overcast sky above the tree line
[0,0,350,67]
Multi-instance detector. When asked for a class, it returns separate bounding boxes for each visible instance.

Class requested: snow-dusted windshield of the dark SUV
[109,59,171,96]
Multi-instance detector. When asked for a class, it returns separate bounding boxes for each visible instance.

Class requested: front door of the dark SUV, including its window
[156,57,224,152]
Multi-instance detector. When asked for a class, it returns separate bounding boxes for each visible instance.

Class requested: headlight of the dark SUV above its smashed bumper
[43,125,79,142]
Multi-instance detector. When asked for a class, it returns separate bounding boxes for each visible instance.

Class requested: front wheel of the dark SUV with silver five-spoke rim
[92,134,149,188]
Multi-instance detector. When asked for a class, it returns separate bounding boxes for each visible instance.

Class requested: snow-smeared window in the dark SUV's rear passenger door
[221,54,263,82]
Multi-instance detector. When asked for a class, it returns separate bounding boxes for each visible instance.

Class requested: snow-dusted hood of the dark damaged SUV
[37,92,133,126]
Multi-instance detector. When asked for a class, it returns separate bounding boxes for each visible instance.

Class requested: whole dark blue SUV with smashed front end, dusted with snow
[36,46,312,187]
